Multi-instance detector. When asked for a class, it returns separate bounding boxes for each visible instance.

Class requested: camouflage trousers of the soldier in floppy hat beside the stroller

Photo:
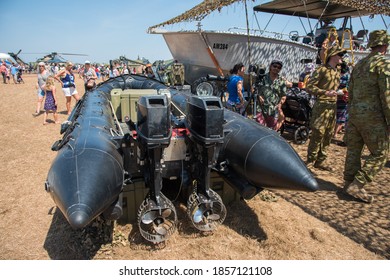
[307,101,337,163]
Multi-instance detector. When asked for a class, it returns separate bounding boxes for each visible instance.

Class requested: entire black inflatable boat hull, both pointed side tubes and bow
[46,75,318,228]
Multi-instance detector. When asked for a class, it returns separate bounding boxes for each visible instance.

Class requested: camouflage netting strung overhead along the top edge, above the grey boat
[149,0,390,30]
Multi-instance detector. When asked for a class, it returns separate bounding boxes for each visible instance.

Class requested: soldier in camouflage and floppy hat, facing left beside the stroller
[306,45,346,171]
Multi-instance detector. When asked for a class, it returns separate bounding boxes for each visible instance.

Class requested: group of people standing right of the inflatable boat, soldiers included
[227,30,390,203]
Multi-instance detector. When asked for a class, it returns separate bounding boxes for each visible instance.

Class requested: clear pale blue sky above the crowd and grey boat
[0,0,390,63]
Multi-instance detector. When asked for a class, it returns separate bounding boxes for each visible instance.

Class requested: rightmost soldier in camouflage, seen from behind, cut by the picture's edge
[344,30,390,203]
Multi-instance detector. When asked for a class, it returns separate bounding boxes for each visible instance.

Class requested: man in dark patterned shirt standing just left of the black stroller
[256,60,287,130]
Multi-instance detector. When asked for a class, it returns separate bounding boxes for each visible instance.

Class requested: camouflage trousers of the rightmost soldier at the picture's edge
[344,116,389,184]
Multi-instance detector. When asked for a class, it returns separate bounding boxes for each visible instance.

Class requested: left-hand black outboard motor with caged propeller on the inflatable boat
[137,95,177,243]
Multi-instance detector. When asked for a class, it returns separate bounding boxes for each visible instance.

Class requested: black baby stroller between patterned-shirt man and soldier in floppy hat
[280,88,314,144]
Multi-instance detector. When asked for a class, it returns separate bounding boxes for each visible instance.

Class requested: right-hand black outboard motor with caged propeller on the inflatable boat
[187,96,226,231]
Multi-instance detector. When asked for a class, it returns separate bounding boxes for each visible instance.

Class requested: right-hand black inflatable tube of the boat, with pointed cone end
[172,89,318,191]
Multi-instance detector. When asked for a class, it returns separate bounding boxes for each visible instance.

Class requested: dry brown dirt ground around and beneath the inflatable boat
[0,74,390,260]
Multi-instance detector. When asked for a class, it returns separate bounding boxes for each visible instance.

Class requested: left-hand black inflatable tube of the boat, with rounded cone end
[47,88,123,228]
